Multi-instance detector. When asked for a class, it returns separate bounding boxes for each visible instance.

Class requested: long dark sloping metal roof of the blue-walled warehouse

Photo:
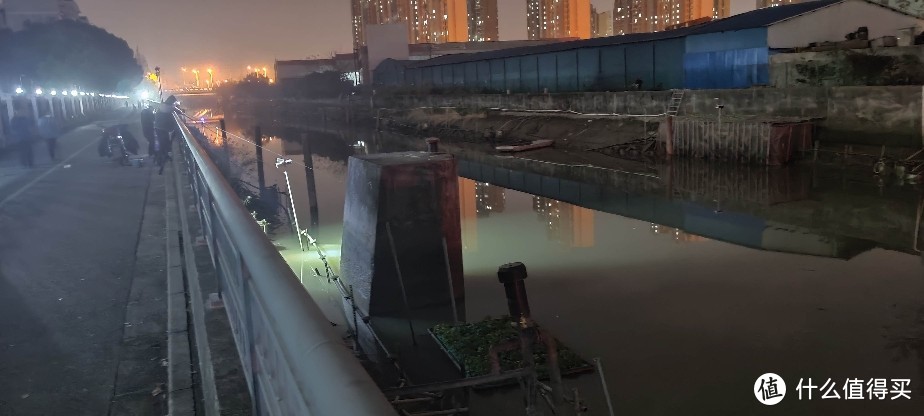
[408,0,845,68]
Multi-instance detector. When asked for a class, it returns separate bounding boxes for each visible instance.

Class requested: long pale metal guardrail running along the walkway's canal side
[174,115,397,416]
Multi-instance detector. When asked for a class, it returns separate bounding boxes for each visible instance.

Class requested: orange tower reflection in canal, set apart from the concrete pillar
[533,196,594,247]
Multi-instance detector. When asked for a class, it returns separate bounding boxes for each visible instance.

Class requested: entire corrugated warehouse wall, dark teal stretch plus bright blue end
[405,28,770,92]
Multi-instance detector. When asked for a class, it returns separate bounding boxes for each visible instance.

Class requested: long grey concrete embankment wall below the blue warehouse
[375,86,924,148]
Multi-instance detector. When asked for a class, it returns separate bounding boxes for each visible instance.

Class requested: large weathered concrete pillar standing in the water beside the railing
[341,152,465,322]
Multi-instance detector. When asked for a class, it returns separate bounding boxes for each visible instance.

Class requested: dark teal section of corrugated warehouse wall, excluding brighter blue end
[405,38,685,92]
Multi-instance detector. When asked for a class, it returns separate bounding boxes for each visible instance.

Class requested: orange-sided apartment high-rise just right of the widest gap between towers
[526,0,591,39]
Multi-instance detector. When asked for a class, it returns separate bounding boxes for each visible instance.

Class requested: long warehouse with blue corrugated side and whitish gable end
[374,0,924,92]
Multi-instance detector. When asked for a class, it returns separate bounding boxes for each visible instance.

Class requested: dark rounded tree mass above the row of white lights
[0,20,143,93]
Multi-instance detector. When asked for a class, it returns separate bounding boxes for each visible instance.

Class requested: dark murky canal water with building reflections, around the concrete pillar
[182,98,924,415]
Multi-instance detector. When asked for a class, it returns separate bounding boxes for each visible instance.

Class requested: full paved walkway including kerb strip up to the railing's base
[0,109,251,416]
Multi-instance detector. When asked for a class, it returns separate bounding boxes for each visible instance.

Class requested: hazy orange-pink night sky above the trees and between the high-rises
[77,0,613,84]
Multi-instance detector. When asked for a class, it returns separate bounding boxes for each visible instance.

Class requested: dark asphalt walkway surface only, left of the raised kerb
[0,109,167,416]
